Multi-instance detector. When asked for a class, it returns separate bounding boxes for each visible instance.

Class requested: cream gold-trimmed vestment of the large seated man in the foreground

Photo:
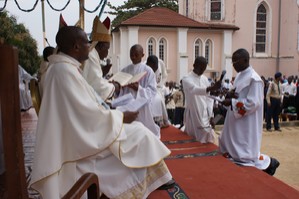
[30,53,172,199]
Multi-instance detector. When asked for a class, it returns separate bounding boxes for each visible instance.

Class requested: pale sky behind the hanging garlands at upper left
[0,0,125,55]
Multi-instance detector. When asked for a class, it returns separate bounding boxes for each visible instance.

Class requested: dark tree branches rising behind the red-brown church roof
[107,0,178,27]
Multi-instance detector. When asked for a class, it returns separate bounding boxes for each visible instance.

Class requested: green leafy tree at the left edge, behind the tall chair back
[0,11,41,74]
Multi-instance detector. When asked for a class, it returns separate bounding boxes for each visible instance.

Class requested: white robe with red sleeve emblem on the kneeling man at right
[219,66,270,169]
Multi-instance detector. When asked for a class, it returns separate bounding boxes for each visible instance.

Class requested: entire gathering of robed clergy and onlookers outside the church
[23,14,292,198]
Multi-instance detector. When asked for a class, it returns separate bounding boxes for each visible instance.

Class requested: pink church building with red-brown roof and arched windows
[110,0,299,82]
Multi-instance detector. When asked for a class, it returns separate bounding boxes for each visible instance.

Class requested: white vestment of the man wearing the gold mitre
[82,48,115,100]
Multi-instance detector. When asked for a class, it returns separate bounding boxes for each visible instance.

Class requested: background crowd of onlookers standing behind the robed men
[164,65,299,132]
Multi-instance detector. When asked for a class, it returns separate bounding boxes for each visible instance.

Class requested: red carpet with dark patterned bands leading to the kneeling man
[148,126,299,199]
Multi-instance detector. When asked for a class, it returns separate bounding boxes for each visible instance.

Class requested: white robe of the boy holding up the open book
[119,63,160,138]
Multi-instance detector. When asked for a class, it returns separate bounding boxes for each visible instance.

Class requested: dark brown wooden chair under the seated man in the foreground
[0,44,100,199]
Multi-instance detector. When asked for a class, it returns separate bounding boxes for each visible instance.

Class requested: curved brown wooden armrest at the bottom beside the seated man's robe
[62,173,100,199]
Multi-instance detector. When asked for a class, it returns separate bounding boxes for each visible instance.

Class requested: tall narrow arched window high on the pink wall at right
[255,4,267,53]
